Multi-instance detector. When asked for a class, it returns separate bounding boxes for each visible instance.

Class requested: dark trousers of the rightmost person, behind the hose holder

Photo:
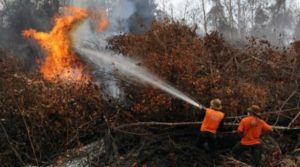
[232,143,262,167]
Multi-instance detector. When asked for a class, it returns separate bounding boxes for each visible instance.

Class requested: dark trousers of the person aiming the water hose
[197,132,217,155]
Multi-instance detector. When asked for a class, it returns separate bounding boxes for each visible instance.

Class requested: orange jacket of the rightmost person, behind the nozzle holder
[238,116,272,145]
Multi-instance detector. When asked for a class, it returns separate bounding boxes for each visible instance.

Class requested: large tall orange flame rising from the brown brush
[23,7,90,82]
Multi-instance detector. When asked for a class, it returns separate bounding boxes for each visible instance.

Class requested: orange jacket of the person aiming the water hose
[200,108,224,134]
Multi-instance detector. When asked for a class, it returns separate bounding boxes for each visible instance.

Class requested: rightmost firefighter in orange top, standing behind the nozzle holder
[232,105,273,167]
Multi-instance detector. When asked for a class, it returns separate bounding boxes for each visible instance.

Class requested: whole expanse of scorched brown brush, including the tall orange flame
[0,0,300,167]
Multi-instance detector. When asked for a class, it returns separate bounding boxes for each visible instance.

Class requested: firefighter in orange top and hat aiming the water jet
[197,99,224,156]
